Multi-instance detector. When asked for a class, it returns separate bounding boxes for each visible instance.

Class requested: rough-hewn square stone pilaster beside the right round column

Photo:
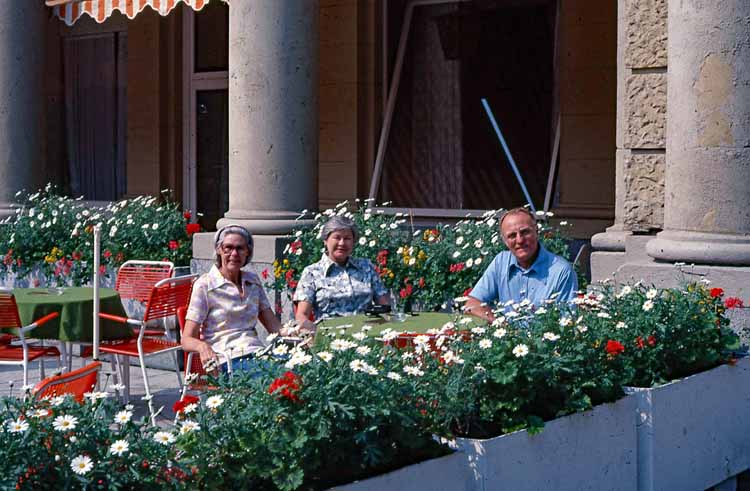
[591,0,667,281]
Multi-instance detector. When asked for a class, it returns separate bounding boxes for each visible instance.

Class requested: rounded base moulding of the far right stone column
[646,230,750,266]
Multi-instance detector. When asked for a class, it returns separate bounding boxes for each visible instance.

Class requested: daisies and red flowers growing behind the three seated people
[269,200,569,310]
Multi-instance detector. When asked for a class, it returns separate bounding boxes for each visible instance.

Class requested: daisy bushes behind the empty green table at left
[0,184,198,286]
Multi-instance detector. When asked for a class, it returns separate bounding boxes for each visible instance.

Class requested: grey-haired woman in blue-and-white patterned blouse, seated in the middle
[293,216,390,329]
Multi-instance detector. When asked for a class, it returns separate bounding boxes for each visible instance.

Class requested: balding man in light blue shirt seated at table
[466,208,578,322]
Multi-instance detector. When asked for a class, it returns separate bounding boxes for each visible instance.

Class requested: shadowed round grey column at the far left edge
[0,1,47,218]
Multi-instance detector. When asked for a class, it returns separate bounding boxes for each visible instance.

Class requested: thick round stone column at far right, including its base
[647,0,750,268]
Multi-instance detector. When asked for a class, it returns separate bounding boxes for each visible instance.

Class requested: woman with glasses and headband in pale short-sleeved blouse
[182,225,281,371]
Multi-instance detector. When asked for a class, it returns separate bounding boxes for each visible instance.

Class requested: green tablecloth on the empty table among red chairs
[13,287,131,342]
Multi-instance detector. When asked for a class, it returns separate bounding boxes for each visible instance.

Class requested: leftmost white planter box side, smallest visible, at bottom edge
[332,452,476,491]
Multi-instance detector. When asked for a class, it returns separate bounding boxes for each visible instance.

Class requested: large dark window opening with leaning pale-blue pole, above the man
[380,0,556,209]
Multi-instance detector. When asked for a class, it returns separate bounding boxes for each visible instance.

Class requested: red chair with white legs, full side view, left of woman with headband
[99,275,198,424]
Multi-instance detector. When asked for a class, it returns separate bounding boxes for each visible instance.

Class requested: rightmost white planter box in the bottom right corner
[632,358,750,491]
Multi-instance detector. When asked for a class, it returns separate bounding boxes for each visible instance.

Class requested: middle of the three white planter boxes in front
[456,397,636,491]
